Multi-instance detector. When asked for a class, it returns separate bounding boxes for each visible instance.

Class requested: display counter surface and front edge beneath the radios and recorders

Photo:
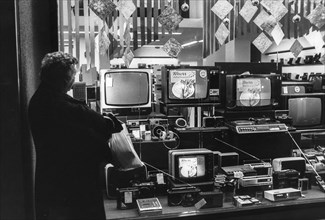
[104,186,325,220]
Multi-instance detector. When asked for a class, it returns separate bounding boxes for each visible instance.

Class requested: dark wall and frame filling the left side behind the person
[0,0,58,220]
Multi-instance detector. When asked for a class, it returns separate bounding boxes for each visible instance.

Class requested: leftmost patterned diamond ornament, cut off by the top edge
[89,0,116,20]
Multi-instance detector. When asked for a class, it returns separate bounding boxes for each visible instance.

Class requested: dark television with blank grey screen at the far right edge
[281,93,325,130]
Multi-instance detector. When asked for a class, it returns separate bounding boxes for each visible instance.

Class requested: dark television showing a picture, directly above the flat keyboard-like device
[220,74,281,111]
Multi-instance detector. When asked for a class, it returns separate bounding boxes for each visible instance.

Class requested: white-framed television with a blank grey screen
[100,69,152,116]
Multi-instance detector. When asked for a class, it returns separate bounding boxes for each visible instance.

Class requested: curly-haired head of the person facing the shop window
[40,51,78,84]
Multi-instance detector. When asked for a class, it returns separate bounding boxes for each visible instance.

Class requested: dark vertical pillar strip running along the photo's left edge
[0,0,26,220]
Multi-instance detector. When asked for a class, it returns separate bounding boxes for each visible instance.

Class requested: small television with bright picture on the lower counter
[168,148,214,191]
